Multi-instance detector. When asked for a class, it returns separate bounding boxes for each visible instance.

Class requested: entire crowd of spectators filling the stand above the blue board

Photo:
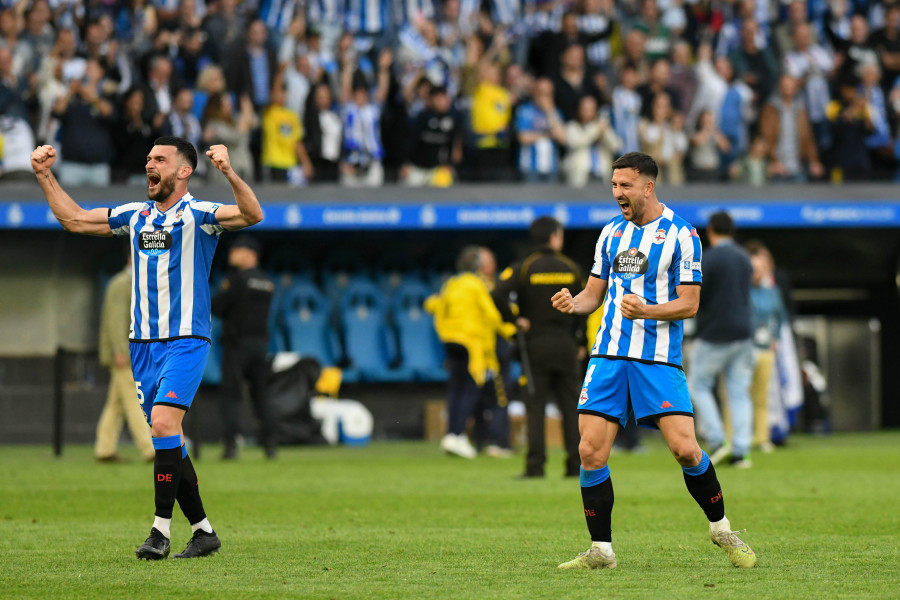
[0,0,900,186]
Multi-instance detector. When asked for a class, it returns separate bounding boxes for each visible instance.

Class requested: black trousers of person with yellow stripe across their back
[525,337,581,475]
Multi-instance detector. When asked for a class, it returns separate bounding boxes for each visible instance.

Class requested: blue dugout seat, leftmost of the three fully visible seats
[278,281,340,366]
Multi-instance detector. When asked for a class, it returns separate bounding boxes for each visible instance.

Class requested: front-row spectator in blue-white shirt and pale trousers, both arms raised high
[341,50,393,187]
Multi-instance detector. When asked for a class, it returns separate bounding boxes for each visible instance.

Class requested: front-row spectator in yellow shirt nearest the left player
[262,77,313,186]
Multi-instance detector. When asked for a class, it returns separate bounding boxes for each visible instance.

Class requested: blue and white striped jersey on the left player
[109,194,225,341]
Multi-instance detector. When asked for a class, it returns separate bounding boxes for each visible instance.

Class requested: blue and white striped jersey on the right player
[591,205,703,368]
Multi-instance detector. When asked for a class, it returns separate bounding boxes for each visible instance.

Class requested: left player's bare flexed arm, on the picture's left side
[31,146,112,236]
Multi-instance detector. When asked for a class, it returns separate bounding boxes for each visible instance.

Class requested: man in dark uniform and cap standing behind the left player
[212,235,277,460]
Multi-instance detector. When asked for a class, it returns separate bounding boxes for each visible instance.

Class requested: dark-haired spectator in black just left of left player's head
[112,88,159,186]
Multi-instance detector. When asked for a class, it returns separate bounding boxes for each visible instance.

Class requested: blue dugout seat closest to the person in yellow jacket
[391,282,447,381]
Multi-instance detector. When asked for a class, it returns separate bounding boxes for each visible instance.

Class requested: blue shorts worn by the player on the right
[578,358,694,429]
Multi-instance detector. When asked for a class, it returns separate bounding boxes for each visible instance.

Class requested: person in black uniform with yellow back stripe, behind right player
[494,217,585,477]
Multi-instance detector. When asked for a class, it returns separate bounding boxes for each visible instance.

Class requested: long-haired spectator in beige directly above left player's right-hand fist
[201,93,257,179]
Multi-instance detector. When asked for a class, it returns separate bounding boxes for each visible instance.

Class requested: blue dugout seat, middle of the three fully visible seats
[339,281,412,382]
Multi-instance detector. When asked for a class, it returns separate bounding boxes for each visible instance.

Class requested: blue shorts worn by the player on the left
[129,338,209,423]
